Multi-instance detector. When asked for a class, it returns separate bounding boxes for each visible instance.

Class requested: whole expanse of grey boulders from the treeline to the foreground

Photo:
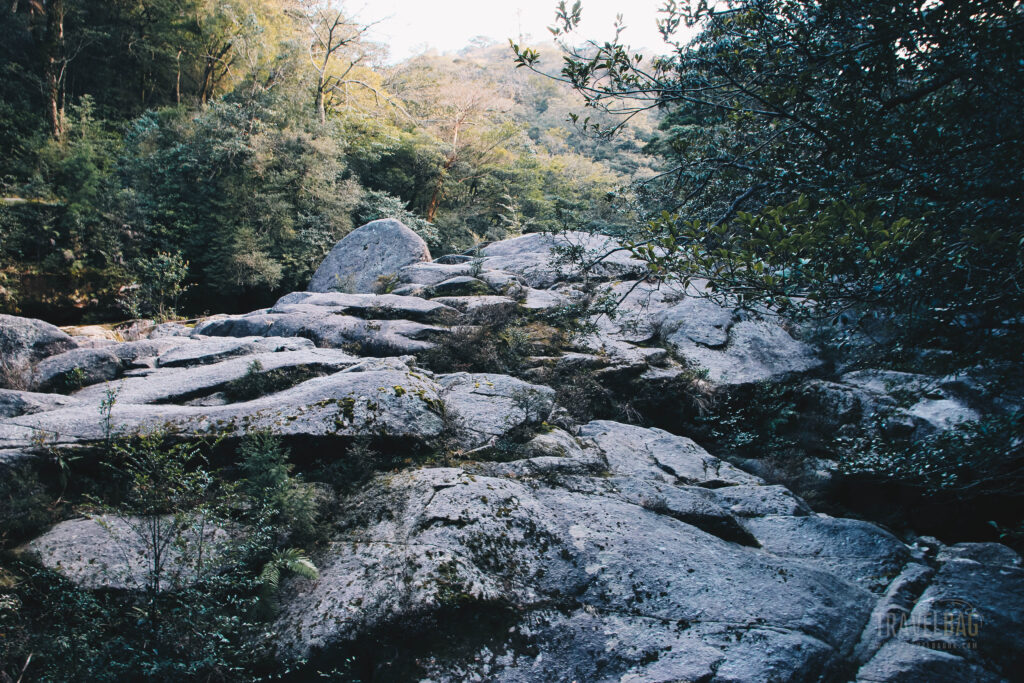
[0,220,1024,682]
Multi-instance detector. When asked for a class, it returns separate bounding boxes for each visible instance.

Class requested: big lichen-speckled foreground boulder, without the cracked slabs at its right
[278,422,897,682]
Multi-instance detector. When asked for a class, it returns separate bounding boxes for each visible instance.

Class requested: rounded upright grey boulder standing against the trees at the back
[309,218,430,293]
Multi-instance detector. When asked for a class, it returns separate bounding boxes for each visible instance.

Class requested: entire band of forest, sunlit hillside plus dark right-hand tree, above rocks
[0,0,1024,368]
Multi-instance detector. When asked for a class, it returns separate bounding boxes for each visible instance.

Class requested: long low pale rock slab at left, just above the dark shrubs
[0,360,554,449]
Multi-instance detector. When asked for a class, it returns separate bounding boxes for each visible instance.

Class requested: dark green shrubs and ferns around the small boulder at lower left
[0,431,333,681]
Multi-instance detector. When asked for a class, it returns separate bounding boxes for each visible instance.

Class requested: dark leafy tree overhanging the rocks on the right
[513,0,1024,366]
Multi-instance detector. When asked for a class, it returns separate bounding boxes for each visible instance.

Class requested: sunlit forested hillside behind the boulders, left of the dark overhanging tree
[0,0,652,322]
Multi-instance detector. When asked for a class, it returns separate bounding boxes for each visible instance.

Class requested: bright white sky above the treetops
[356,0,684,61]
